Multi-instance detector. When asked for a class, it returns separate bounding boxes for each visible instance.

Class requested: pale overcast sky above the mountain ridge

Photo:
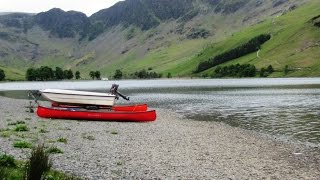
[0,0,120,16]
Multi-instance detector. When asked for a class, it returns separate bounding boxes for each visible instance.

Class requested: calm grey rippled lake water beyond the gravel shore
[0,78,320,146]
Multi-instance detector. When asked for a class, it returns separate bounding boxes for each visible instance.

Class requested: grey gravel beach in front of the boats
[0,97,320,179]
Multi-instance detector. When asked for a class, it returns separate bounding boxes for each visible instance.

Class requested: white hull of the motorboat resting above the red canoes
[40,89,116,106]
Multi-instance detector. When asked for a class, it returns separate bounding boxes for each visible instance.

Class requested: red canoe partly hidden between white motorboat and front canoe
[52,103,148,111]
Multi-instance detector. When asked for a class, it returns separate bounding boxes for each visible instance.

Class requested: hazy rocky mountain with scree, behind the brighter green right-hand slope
[0,0,319,80]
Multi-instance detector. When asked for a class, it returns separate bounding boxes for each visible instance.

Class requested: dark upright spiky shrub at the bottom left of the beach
[24,145,52,180]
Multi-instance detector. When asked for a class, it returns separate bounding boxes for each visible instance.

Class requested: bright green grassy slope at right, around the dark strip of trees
[185,0,320,76]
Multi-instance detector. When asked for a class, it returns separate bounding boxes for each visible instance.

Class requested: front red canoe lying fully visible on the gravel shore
[37,106,156,122]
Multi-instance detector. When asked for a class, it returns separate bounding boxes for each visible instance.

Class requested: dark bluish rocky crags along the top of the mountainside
[0,0,298,40]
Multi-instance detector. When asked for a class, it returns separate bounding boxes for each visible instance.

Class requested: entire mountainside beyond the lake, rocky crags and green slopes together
[0,0,320,79]
